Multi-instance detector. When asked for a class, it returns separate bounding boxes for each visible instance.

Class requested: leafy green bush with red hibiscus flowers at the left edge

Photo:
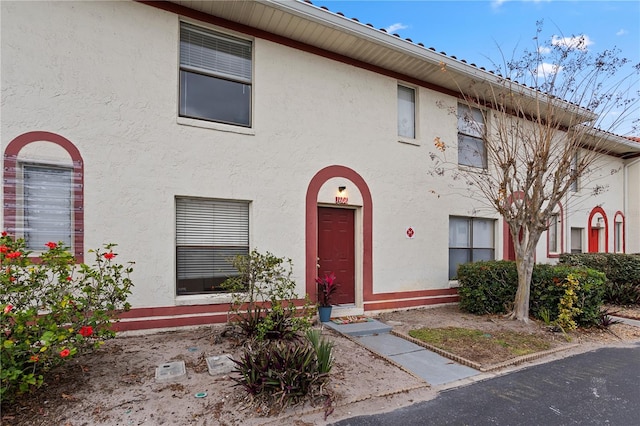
[0,232,133,401]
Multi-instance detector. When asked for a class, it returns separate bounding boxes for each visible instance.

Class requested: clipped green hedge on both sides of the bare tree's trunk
[458,260,605,326]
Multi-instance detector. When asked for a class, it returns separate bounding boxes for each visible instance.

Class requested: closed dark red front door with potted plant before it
[318,207,356,305]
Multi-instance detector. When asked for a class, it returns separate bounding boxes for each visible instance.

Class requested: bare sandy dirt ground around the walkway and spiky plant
[2,305,640,426]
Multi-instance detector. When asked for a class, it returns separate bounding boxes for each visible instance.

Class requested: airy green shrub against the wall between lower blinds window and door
[222,249,313,340]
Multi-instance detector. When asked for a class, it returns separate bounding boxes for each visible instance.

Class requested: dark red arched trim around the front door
[305,165,373,300]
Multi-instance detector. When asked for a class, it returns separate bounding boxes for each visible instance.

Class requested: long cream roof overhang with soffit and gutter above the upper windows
[161,0,640,155]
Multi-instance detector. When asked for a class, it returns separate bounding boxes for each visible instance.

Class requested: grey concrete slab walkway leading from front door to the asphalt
[323,320,480,386]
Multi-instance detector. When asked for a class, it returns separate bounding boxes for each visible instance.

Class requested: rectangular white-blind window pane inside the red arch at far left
[22,165,73,251]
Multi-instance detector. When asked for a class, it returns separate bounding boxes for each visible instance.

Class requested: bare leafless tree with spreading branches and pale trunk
[430,23,640,322]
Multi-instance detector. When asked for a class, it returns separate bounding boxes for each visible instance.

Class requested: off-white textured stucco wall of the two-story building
[1,2,637,314]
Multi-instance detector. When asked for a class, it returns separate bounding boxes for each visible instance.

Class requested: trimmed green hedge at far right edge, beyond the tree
[560,253,640,305]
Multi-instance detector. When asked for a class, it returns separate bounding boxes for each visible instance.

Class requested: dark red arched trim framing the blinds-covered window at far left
[3,131,84,262]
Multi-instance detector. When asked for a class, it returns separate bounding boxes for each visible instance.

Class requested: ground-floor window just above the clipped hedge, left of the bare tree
[449,216,495,279]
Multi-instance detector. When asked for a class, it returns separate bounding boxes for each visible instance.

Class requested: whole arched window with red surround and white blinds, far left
[3,131,84,262]
